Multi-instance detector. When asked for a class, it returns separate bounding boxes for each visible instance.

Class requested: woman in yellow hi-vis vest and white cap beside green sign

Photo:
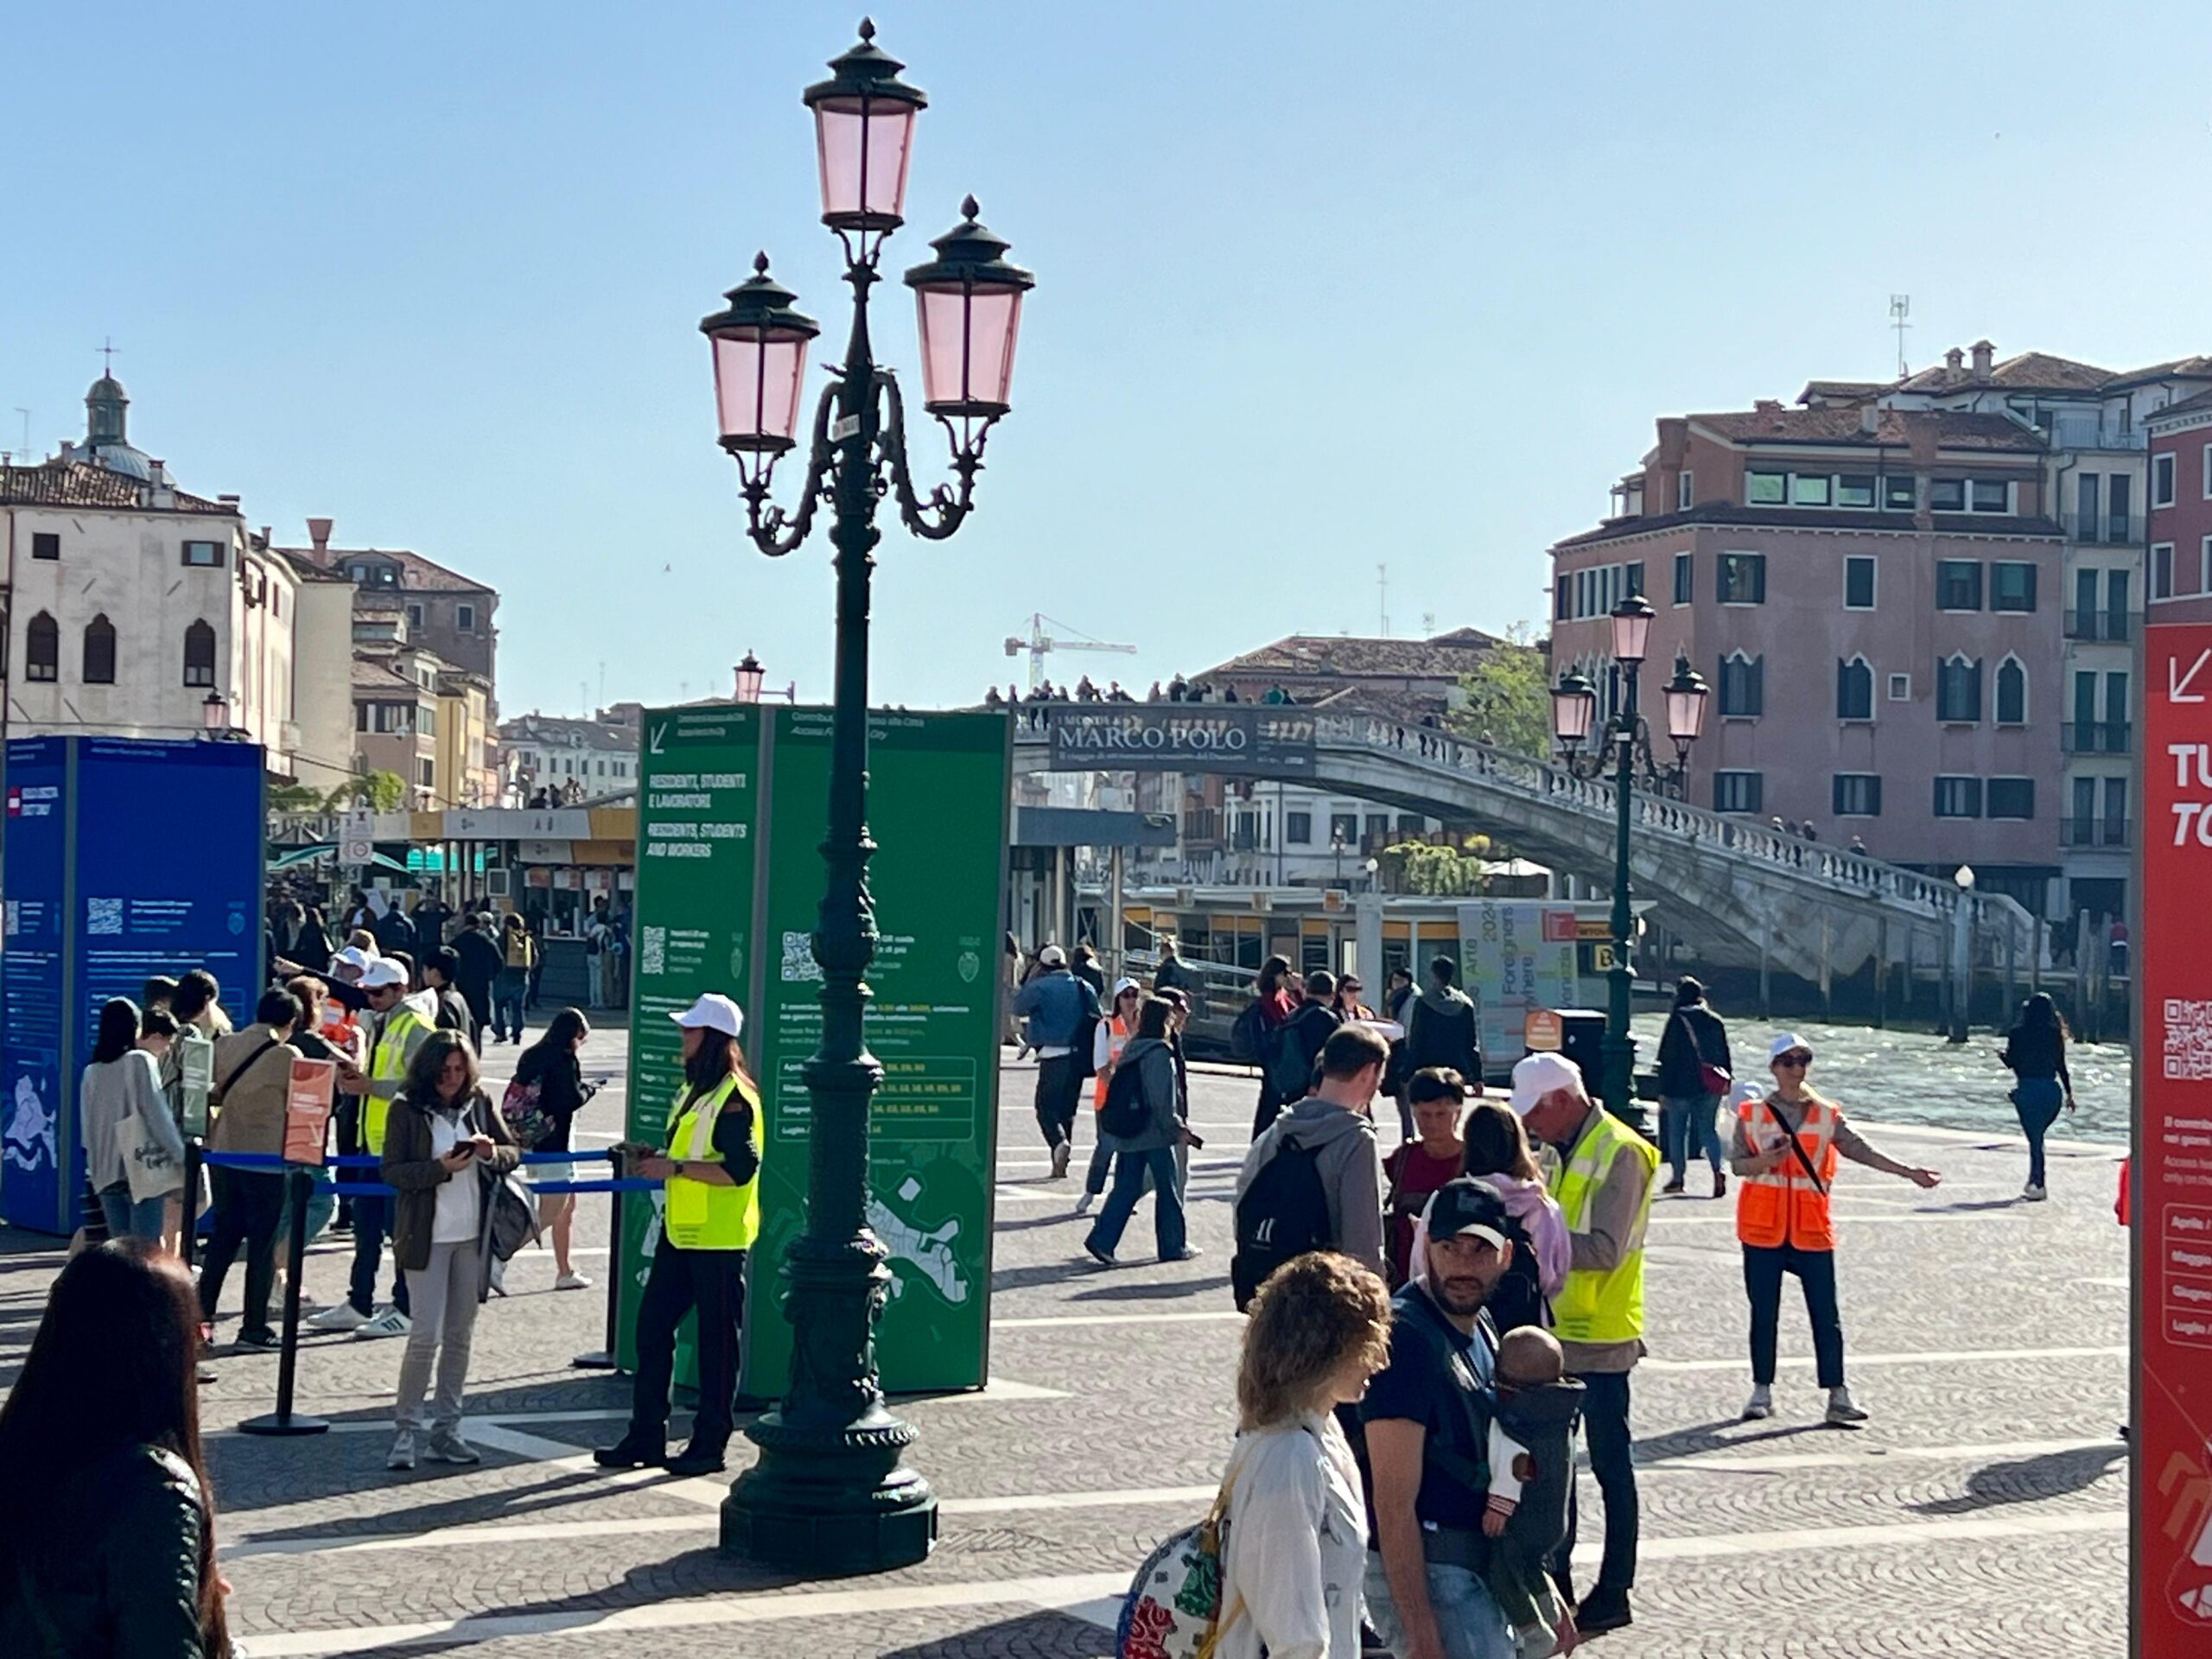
[593,991,761,1476]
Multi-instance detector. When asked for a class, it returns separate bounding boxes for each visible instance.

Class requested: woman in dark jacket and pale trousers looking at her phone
[383,1031,522,1469]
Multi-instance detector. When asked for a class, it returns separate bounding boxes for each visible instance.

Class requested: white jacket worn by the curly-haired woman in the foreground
[1214,1414,1367,1659]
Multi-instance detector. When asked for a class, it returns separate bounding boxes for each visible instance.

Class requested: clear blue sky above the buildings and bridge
[13,0,2212,712]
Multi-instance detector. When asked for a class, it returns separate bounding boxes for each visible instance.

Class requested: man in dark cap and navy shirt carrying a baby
[1360,1177,1513,1659]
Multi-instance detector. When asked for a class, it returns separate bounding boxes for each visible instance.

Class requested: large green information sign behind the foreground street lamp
[620,706,1011,1398]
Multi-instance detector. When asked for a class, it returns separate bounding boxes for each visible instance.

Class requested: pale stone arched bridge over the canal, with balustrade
[1013,703,2039,988]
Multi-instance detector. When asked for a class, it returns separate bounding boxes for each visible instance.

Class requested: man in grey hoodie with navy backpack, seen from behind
[1230,1027,1389,1307]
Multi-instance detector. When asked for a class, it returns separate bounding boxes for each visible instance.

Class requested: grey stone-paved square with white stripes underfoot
[0,1033,2126,1659]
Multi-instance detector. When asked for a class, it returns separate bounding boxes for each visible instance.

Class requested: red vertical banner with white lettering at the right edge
[2128,624,2212,1659]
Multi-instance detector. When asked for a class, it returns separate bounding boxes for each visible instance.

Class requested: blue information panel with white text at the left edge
[0,736,264,1232]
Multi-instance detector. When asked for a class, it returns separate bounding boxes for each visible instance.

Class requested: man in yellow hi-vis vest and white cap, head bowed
[1513,1053,1659,1635]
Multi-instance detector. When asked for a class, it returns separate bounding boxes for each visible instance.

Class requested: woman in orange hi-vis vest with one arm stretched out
[1727,1031,1940,1429]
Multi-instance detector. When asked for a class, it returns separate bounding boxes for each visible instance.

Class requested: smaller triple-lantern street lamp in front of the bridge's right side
[1551,595,1707,1130]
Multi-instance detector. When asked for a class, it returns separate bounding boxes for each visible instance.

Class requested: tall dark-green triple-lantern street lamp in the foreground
[699,20,1035,1573]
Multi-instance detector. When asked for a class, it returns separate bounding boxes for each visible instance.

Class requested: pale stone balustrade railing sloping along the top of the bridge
[1011,703,2031,940]
